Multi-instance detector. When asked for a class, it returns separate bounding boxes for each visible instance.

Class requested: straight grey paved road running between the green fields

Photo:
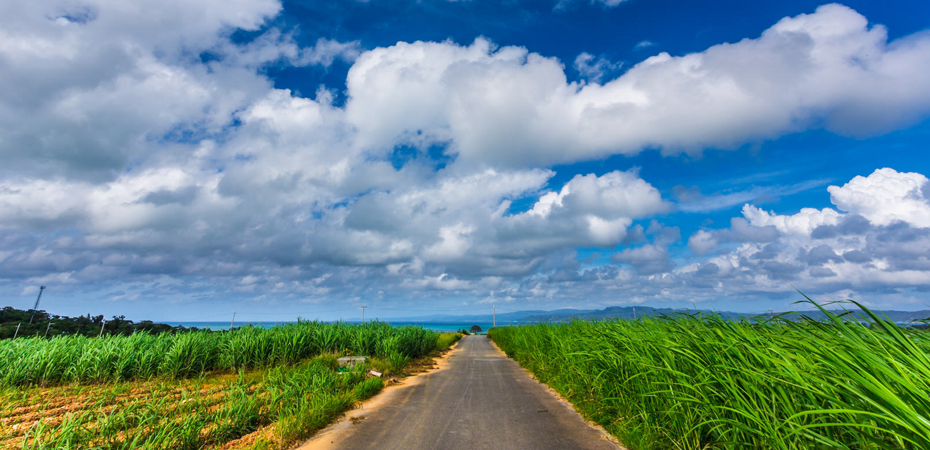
[301,336,618,450]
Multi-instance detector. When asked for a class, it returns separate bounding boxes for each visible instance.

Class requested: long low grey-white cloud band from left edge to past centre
[0,158,677,289]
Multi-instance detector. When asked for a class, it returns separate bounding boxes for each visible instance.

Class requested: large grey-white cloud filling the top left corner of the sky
[0,0,298,181]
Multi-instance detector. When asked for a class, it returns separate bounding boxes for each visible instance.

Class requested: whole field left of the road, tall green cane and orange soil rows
[0,322,461,449]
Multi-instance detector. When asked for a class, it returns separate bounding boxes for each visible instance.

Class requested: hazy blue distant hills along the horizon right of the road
[395,306,930,325]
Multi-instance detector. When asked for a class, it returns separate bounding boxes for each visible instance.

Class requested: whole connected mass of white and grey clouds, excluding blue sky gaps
[0,0,930,312]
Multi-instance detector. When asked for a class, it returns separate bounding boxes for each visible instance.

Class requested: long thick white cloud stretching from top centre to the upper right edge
[347,4,930,166]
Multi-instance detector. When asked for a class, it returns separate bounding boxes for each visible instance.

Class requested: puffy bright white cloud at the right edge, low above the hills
[688,168,930,293]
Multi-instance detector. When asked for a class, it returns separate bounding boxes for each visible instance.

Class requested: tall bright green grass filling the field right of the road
[489,305,930,450]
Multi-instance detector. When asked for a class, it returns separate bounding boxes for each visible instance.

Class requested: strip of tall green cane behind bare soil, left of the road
[0,322,439,386]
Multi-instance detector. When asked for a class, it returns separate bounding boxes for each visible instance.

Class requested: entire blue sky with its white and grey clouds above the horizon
[0,0,930,321]
